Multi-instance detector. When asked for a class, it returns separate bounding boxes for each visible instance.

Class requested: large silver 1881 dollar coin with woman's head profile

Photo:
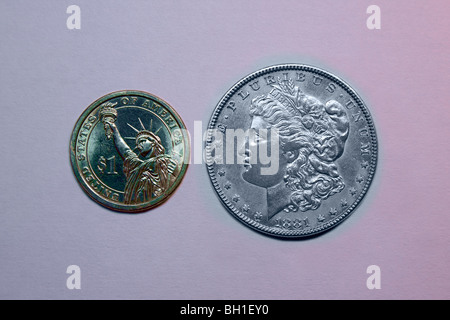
[205,64,378,238]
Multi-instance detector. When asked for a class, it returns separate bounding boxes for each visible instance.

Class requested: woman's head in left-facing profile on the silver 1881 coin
[242,80,349,219]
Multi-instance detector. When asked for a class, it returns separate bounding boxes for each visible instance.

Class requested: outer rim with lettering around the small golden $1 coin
[69,90,190,213]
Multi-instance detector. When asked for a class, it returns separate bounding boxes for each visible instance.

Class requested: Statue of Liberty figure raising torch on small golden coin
[100,102,178,204]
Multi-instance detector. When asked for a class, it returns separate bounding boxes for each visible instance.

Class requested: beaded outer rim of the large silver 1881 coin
[205,63,378,238]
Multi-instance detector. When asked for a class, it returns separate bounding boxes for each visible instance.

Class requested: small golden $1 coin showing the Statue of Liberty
[70,91,190,213]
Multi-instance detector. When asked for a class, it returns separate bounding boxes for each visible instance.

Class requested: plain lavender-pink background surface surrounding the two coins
[0,0,450,299]
